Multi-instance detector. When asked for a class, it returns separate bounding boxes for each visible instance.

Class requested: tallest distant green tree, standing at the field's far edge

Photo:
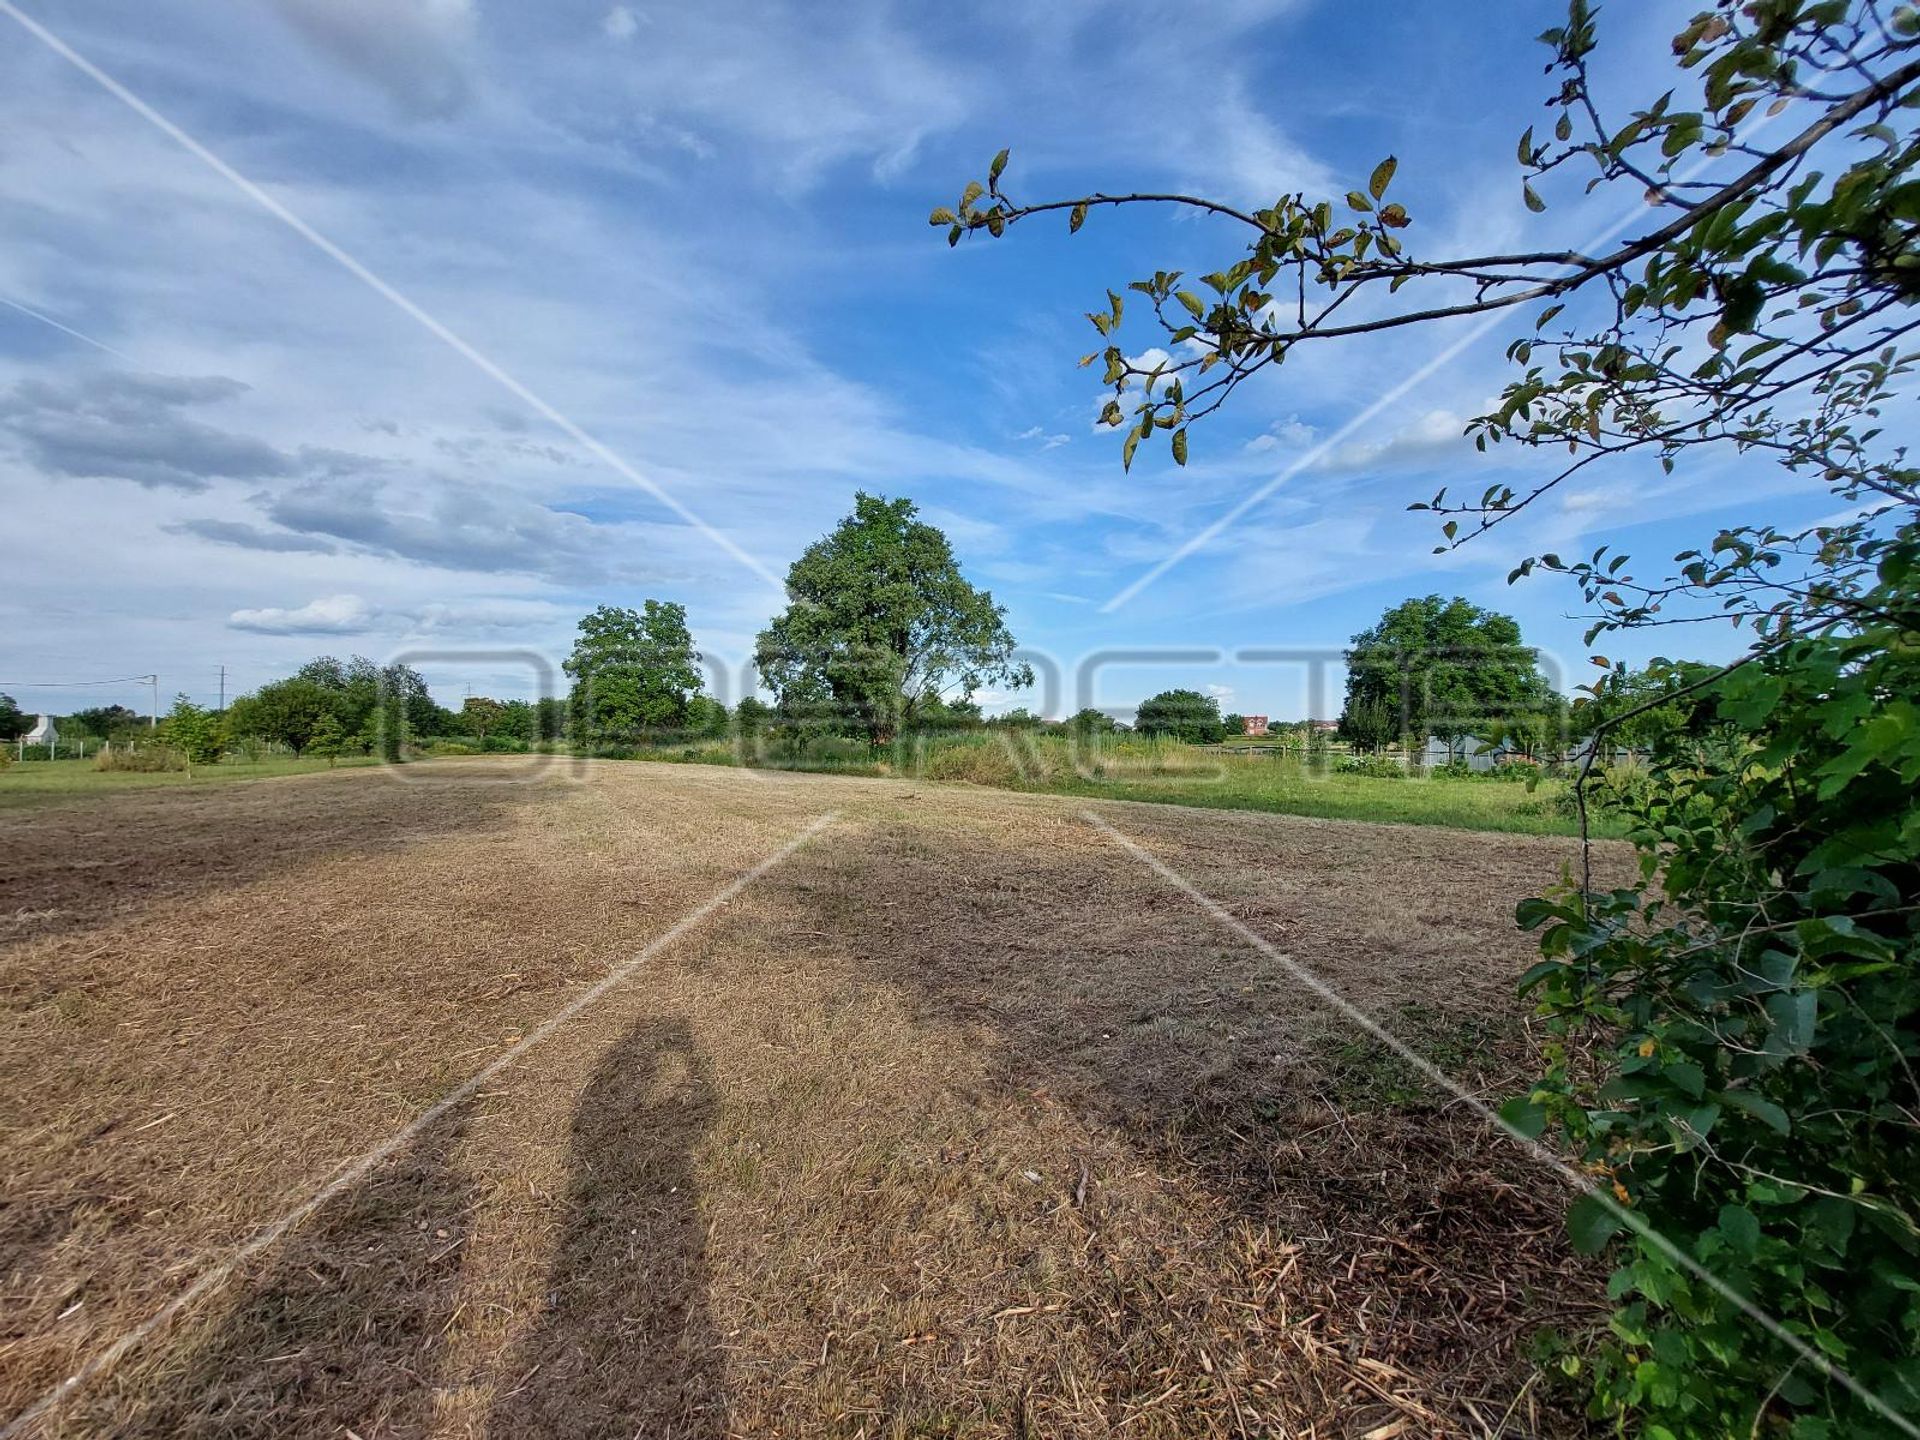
[755,493,1033,745]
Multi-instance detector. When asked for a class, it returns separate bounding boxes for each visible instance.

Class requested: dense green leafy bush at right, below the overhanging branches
[1521,526,1920,1436]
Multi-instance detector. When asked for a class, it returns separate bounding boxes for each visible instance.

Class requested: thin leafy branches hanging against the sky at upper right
[931,0,1920,618]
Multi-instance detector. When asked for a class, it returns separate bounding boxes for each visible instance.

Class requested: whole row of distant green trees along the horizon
[0,493,1712,758]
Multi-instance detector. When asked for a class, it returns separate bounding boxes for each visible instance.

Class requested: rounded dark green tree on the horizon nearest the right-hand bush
[1340,595,1559,747]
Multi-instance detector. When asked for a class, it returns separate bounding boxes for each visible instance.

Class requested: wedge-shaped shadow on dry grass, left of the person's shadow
[84,1106,476,1440]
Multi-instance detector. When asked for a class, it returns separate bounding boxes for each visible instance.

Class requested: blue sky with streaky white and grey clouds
[0,0,1824,716]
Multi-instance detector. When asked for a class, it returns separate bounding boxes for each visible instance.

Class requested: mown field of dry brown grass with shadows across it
[0,760,1620,1440]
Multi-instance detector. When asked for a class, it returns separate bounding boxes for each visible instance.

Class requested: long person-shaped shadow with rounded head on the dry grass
[488,1020,726,1440]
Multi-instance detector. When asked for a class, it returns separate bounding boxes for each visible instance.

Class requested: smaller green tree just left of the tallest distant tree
[566,599,701,745]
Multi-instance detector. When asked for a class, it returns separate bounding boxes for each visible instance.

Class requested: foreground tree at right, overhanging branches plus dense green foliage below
[931,0,1920,1440]
